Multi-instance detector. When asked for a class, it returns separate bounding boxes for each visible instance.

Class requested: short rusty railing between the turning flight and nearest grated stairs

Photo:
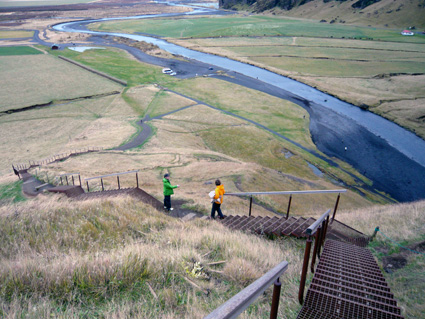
[298,209,331,305]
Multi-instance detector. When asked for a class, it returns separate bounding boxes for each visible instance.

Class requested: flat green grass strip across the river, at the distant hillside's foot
[92,16,425,43]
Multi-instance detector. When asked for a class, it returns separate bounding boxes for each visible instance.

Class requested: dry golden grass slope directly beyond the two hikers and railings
[34,101,370,216]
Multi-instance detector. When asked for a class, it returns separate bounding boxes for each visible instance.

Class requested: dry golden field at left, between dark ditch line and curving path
[0,95,136,175]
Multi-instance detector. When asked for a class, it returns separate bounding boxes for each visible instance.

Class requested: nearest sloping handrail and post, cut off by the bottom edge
[204,261,288,319]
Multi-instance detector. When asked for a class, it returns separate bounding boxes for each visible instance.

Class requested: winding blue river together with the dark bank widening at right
[54,2,425,201]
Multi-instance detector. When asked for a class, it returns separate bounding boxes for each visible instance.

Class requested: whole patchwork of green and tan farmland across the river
[93,16,425,138]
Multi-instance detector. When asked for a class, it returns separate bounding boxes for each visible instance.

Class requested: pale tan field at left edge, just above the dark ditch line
[0,54,122,111]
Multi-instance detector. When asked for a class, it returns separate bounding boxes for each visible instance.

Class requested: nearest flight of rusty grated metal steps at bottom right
[298,240,403,319]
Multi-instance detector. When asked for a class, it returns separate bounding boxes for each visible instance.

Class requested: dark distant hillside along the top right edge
[219,0,425,29]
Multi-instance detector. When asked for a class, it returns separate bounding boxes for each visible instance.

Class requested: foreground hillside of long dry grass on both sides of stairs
[0,195,425,318]
